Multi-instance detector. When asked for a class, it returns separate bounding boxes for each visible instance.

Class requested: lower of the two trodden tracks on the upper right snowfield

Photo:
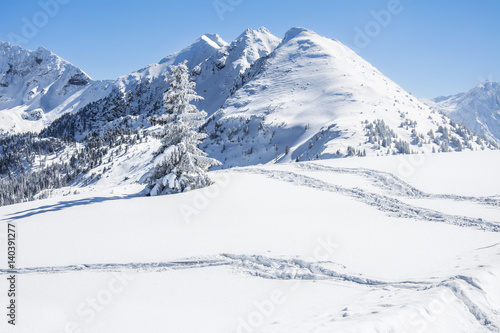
[231,167,500,232]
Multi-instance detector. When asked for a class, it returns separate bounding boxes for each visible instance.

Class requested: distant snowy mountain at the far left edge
[0,41,110,134]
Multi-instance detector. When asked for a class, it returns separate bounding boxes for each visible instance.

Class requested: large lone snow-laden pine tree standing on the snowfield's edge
[149,62,220,196]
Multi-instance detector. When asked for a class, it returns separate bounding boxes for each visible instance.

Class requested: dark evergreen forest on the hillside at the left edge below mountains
[0,128,146,206]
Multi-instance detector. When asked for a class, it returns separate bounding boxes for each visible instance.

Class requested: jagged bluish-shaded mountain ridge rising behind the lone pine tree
[40,28,280,139]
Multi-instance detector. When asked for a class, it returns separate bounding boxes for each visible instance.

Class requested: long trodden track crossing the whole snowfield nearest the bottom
[0,254,498,332]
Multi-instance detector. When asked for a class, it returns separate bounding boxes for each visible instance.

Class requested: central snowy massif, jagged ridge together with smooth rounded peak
[39,28,496,161]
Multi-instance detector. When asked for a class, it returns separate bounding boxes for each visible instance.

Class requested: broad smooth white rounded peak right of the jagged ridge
[204,28,492,167]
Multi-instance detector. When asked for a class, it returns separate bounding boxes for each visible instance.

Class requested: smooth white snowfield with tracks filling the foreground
[0,151,500,333]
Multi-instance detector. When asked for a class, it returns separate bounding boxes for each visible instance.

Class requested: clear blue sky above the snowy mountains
[0,0,500,97]
